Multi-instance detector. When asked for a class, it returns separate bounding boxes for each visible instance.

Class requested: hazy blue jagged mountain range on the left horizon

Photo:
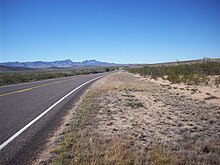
[0,59,118,68]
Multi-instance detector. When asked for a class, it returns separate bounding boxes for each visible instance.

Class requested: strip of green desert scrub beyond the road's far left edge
[0,67,115,86]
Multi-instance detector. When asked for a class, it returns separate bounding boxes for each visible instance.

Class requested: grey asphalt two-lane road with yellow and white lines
[0,73,106,165]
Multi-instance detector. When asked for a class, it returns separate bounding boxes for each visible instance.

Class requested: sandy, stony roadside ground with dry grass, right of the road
[32,72,220,164]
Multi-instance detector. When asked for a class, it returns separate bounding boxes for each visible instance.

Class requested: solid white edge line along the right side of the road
[0,75,105,150]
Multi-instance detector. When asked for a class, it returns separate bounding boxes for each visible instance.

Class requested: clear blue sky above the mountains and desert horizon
[0,0,220,63]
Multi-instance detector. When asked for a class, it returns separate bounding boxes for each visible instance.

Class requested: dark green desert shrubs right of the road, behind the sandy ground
[127,62,220,85]
